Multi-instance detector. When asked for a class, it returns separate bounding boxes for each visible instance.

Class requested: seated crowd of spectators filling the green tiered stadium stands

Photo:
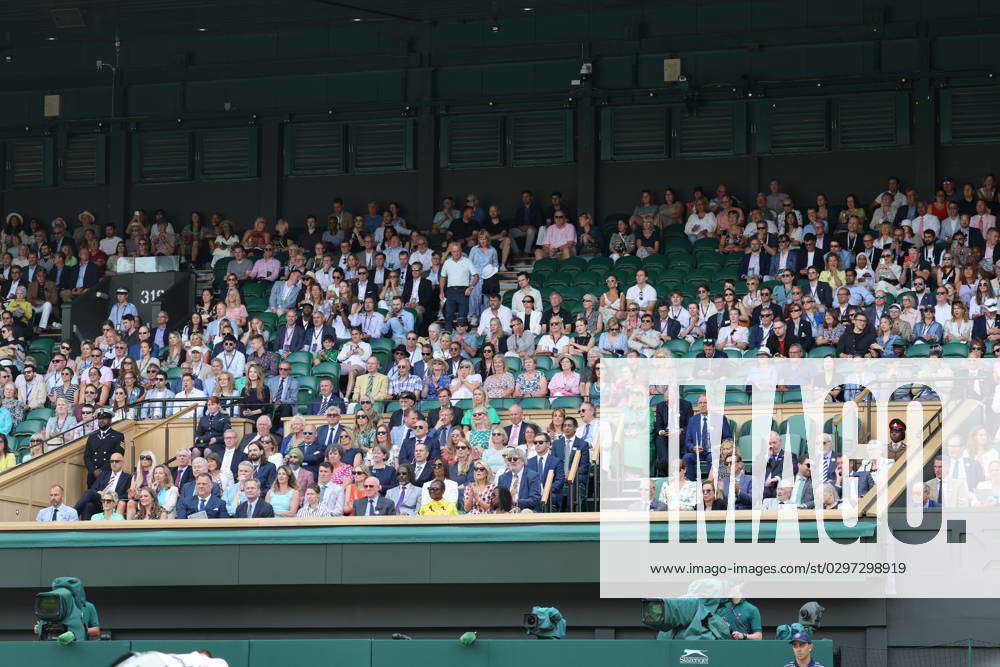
[11,175,1000,520]
